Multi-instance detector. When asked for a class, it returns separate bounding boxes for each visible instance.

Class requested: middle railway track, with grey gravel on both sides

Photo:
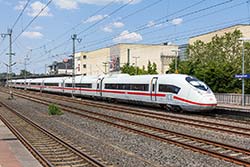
[4,89,250,167]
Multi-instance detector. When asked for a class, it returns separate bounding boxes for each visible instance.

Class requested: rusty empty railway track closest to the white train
[9,88,250,137]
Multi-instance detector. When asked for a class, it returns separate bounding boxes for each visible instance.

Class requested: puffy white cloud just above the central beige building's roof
[113,30,142,43]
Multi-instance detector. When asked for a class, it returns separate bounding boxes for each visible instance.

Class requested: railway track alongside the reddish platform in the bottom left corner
[0,102,108,167]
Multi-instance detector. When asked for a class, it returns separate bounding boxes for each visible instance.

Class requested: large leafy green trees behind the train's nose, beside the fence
[170,30,247,93]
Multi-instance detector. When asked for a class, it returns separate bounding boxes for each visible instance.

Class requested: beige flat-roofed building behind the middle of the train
[75,44,178,75]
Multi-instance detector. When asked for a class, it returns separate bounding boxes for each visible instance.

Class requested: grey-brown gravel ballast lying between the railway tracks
[0,93,246,167]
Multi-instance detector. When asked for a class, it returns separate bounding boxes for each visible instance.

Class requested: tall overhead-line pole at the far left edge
[1,29,16,99]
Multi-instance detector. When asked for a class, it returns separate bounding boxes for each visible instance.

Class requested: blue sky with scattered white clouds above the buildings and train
[0,0,250,73]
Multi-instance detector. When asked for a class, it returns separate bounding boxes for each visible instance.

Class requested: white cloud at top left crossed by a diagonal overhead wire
[28,1,52,17]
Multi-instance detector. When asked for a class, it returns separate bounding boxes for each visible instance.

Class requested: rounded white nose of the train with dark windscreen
[176,76,217,112]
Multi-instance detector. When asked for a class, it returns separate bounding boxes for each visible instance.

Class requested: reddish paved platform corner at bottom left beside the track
[0,120,42,167]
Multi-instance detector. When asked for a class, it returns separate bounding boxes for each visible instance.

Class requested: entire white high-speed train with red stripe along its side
[10,74,217,111]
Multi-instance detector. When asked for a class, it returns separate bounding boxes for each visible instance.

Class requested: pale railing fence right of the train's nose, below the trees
[215,93,250,105]
